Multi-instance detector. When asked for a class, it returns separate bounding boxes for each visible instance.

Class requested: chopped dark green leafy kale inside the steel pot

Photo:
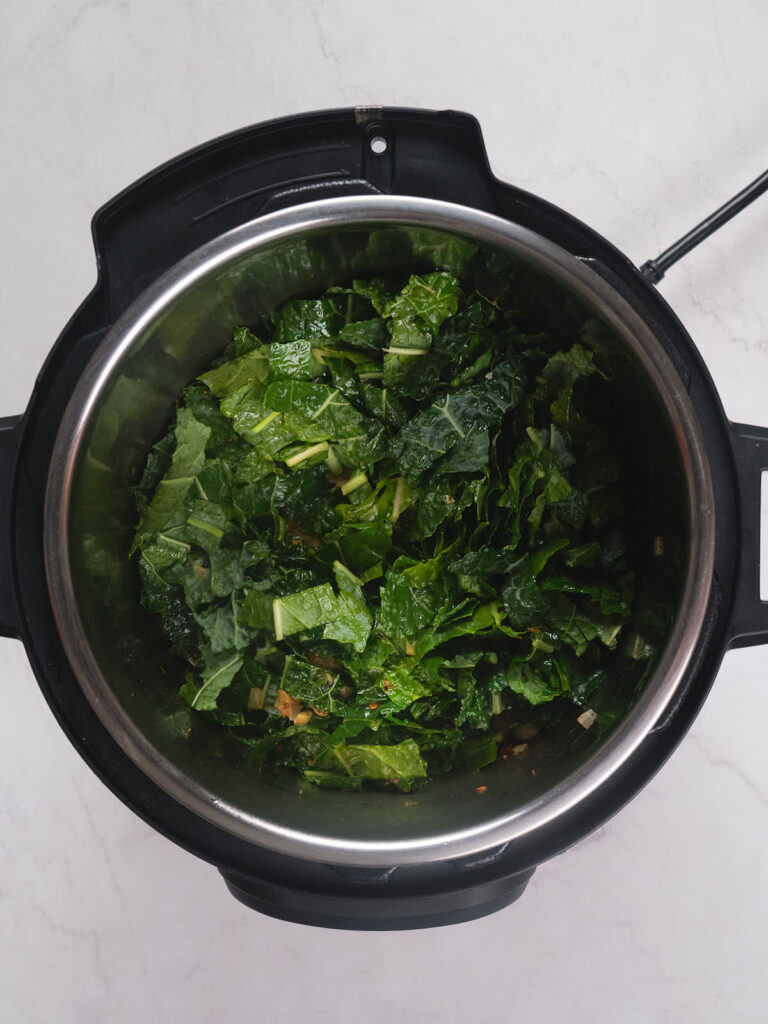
[133,270,654,792]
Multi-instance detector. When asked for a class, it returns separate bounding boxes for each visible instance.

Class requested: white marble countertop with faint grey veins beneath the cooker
[0,0,768,1024]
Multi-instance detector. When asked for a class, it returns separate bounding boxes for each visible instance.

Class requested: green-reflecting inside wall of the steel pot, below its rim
[55,214,689,846]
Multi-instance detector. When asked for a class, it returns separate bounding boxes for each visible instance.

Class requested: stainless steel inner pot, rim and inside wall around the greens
[45,196,715,866]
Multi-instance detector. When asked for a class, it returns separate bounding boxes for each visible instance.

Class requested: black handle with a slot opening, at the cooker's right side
[728,423,768,647]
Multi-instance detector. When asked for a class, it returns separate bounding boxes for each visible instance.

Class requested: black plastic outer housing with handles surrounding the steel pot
[0,109,757,929]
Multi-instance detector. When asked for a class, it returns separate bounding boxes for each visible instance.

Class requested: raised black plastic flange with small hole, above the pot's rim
[92,106,496,323]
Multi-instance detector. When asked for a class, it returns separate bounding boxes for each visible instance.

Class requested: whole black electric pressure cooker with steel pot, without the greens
[0,109,768,929]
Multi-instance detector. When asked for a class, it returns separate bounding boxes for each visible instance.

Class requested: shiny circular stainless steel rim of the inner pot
[43,196,715,866]
